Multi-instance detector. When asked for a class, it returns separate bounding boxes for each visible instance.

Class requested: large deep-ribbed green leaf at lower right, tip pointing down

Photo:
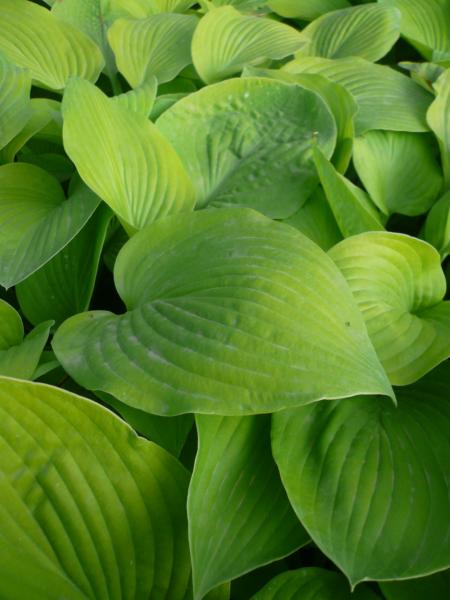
[272,362,450,585]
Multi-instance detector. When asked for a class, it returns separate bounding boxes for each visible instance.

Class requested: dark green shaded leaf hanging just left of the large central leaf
[16,205,111,325]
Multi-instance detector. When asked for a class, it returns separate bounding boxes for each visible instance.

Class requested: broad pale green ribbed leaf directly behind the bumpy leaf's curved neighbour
[283,57,432,135]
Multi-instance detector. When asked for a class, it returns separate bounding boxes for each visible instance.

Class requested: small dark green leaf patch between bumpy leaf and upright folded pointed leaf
[284,188,342,251]
